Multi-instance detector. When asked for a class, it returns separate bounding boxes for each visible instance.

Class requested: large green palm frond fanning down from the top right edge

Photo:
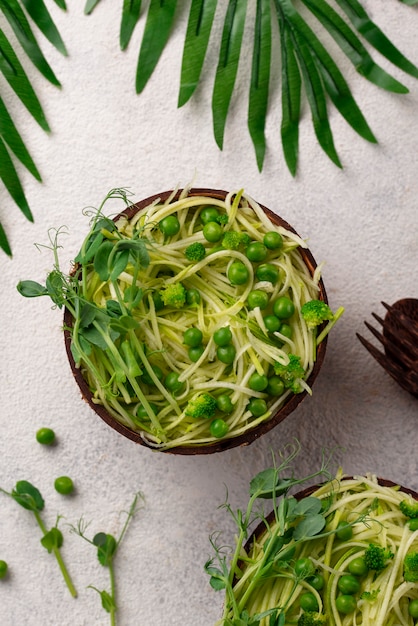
[85,0,418,175]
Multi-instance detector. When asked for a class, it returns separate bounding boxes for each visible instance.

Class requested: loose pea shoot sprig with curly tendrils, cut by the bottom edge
[70,492,144,626]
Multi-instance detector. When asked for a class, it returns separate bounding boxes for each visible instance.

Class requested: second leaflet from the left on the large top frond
[136,0,177,93]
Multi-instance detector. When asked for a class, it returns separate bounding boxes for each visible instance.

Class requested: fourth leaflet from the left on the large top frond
[212,0,247,149]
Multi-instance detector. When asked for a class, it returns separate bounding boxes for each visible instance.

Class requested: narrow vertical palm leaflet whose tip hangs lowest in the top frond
[278,13,302,176]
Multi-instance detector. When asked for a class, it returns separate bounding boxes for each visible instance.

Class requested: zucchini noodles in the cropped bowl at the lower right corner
[232,472,418,626]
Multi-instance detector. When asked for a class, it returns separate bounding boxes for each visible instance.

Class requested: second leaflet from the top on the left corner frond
[0,0,60,87]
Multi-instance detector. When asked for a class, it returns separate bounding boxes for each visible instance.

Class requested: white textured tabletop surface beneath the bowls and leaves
[0,0,418,626]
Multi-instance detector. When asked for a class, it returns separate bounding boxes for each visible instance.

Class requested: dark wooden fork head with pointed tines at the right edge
[356,298,418,398]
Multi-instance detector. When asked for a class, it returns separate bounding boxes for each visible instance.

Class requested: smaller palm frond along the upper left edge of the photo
[0,0,67,256]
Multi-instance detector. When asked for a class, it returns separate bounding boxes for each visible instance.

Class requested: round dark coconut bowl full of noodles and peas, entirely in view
[64,188,327,454]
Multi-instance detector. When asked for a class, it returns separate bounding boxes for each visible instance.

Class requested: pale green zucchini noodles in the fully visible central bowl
[73,190,320,450]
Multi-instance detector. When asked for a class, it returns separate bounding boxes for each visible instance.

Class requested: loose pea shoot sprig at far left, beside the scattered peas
[0,480,77,598]
